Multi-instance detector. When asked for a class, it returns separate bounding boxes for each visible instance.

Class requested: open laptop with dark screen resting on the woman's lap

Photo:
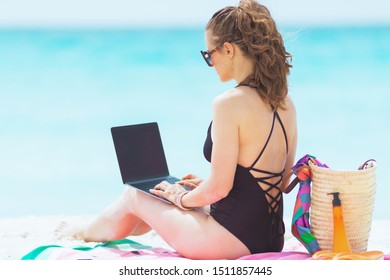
[111,122,179,203]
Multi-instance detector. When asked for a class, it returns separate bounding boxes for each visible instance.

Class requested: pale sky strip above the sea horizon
[0,0,390,27]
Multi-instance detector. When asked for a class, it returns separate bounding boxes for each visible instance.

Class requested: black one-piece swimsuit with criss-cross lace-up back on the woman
[203,111,288,254]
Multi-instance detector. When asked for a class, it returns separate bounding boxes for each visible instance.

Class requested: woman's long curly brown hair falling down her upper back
[206,0,292,110]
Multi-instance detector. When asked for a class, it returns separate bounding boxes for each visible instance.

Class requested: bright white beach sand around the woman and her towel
[0,216,390,260]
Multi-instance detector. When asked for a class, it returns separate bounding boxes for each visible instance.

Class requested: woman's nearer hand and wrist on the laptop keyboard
[150,181,190,210]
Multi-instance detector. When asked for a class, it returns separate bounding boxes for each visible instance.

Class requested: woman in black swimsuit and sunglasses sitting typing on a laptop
[69,0,297,259]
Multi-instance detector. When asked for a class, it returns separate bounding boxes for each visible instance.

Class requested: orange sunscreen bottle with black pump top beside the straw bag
[329,192,351,252]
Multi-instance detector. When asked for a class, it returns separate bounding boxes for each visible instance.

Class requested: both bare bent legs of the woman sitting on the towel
[80,187,250,259]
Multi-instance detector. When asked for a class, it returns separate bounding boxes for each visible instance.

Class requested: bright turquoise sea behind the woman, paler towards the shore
[0,26,390,219]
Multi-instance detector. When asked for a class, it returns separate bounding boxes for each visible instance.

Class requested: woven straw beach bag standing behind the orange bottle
[309,160,377,252]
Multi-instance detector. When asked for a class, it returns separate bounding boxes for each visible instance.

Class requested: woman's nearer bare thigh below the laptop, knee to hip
[126,188,250,259]
